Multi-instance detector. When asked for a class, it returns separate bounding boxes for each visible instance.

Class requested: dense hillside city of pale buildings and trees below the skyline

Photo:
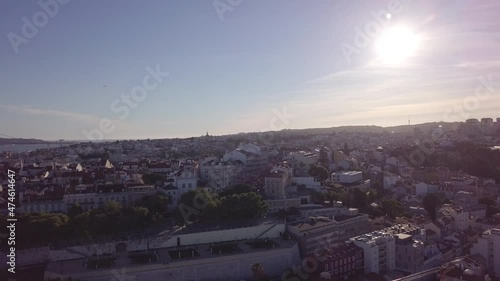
[0,118,500,280]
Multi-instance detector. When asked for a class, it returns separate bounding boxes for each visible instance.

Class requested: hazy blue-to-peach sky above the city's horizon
[0,0,500,140]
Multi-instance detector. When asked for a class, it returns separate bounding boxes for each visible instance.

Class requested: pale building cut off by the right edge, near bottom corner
[470,228,500,277]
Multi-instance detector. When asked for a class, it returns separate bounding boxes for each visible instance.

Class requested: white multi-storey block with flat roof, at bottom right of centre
[350,231,396,274]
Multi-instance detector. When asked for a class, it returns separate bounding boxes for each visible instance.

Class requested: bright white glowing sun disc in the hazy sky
[375,26,420,64]
